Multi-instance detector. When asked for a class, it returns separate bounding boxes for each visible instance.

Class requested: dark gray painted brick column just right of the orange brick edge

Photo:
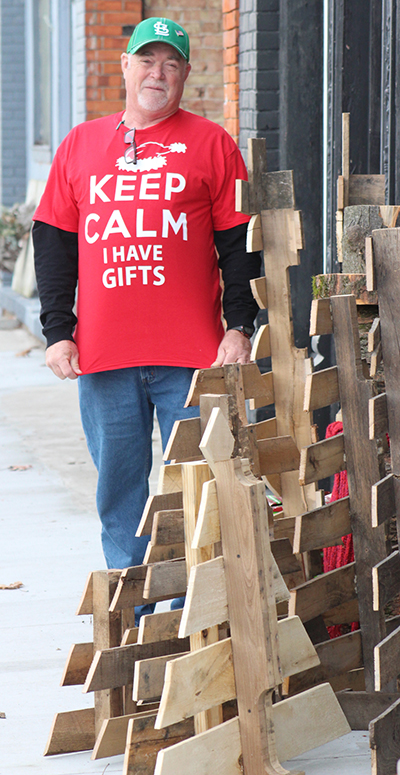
[239,0,279,171]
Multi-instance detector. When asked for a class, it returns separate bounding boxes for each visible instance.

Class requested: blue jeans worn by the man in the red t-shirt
[78,366,198,568]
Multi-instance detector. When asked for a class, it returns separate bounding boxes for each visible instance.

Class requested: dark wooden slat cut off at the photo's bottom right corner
[369,699,400,775]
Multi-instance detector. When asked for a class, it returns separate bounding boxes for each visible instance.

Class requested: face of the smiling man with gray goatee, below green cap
[121,43,190,119]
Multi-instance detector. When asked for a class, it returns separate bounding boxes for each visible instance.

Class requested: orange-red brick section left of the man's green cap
[86,0,142,119]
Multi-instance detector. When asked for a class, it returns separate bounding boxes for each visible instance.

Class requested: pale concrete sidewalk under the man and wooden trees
[0,319,371,775]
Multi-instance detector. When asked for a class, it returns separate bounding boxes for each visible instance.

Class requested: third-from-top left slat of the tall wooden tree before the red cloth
[299,433,346,485]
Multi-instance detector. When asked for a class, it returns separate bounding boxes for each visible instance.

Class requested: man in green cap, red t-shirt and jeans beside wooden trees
[33,18,260,584]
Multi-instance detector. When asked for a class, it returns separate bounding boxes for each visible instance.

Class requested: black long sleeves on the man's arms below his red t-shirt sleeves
[32,221,261,347]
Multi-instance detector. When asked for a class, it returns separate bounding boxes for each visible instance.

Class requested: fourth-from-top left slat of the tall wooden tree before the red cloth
[293,498,351,554]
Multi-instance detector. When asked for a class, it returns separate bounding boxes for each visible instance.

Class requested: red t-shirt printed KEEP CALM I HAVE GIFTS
[34,110,248,373]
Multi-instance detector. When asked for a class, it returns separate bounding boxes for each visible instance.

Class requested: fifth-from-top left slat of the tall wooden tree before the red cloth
[289,563,356,622]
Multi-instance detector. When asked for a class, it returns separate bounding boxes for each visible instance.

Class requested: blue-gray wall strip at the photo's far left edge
[0,0,27,207]
